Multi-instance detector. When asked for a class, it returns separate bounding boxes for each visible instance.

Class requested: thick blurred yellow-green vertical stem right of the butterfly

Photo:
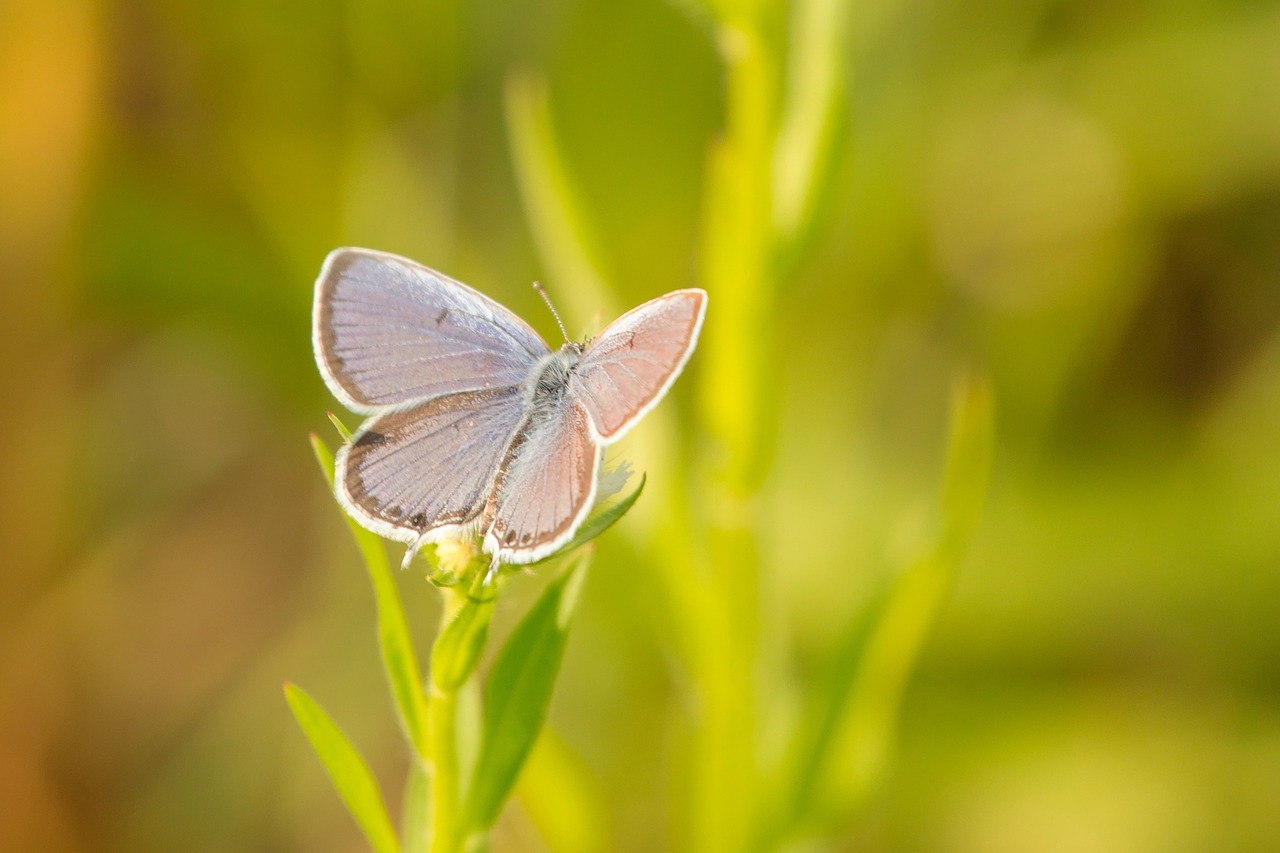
[690,9,778,850]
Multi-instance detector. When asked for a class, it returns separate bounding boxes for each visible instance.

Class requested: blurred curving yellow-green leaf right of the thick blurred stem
[782,371,993,834]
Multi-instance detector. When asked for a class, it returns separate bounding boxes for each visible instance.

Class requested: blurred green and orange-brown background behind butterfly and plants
[0,0,1280,853]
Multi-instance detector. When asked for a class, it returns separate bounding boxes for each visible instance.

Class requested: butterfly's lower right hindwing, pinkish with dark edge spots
[484,400,600,564]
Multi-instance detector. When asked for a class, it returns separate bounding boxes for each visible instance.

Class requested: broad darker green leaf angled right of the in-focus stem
[463,553,589,834]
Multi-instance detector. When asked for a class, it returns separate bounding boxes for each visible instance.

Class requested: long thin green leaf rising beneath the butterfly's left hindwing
[311,434,430,756]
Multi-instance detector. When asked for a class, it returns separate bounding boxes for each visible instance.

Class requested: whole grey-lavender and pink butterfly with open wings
[312,248,707,567]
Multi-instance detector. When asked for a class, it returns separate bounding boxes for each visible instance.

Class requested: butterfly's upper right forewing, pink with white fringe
[570,289,707,442]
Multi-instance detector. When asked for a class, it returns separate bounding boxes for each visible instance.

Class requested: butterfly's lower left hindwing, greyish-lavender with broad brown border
[337,387,525,540]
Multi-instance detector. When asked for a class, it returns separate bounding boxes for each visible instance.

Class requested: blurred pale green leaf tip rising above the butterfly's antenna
[507,77,614,325]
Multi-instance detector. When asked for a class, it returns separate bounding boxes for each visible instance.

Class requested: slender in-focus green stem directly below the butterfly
[428,587,466,853]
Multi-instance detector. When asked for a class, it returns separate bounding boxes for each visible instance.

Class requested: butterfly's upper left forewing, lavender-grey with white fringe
[314,248,548,412]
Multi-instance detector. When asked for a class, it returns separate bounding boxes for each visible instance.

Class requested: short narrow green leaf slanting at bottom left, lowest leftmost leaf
[284,684,401,853]
